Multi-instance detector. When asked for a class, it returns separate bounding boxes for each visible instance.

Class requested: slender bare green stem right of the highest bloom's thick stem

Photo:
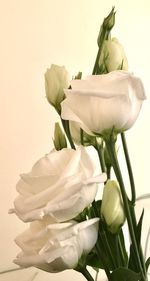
[121,133,136,202]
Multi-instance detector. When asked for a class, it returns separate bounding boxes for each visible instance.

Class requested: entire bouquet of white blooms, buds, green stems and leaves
[10,8,150,281]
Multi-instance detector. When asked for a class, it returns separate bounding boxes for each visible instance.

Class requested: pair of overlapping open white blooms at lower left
[12,146,106,272]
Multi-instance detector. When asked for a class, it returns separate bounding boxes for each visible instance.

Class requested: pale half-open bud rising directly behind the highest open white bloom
[99,38,128,72]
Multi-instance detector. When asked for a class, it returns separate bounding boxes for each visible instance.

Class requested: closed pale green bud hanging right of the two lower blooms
[101,180,125,233]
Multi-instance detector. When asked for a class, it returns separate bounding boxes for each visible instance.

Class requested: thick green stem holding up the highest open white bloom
[106,139,146,281]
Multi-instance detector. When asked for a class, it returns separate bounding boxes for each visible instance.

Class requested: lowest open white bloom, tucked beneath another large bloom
[14,218,99,272]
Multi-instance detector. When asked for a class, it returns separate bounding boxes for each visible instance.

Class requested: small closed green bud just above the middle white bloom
[53,122,67,150]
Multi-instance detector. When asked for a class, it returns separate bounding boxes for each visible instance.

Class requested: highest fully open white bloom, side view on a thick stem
[61,71,145,135]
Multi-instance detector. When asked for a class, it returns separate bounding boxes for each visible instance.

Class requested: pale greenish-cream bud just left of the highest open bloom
[45,64,69,111]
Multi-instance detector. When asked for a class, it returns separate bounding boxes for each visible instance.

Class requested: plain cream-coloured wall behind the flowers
[0,0,150,281]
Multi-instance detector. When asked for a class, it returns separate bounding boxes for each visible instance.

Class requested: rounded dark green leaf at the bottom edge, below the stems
[110,267,140,281]
